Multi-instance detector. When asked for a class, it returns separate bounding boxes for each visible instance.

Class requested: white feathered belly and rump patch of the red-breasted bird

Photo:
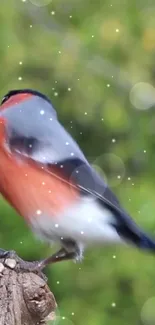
[31,198,121,245]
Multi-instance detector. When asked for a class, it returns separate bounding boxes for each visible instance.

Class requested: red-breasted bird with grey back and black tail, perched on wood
[0,89,155,269]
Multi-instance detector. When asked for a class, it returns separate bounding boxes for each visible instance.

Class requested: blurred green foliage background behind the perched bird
[0,0,155,325]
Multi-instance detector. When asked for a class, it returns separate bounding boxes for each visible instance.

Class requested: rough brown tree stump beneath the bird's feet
[0,254,57,325]
